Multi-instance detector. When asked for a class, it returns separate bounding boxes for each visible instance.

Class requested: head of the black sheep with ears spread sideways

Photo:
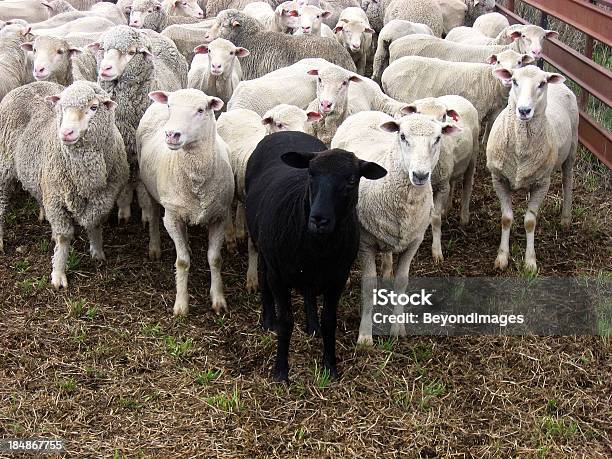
[282,149,387,234]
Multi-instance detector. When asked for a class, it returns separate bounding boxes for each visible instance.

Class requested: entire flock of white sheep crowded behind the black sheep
[0,0,578,343]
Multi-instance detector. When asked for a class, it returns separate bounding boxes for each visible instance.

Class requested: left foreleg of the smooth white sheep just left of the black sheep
[164,210,191,316]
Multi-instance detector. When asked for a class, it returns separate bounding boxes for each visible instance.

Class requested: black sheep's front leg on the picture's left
[268,272,293,382]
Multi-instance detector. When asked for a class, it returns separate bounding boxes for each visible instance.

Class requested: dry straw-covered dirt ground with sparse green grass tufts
[0,146,612,458]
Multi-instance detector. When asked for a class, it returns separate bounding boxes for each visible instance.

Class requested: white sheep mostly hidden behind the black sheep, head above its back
[217,104,321,292]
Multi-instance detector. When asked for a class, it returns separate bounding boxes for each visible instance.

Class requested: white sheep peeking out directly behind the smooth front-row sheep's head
[187,38,249,108]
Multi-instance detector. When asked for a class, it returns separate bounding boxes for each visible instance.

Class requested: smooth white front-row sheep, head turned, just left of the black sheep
[136,89,234,315]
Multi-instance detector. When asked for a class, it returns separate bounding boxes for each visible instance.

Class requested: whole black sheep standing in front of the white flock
[246,132,387,381]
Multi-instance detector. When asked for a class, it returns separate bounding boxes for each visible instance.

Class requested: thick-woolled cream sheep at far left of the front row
[0,81,129,289]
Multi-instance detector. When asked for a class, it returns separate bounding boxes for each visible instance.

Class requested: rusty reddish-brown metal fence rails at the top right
[497,0,612,169]
